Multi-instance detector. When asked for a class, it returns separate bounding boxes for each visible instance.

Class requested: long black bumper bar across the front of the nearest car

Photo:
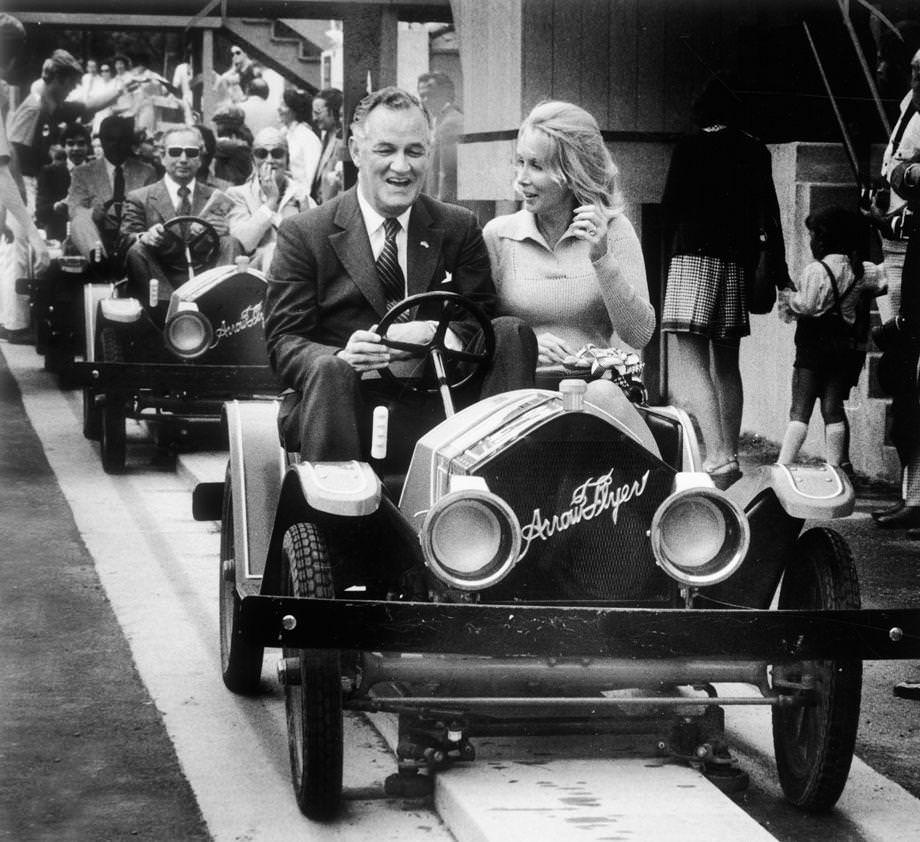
[240,596,920,663]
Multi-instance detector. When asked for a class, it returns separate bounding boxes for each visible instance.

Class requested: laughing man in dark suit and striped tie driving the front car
[265,88,536,461]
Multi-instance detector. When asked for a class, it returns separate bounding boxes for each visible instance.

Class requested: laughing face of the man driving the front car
[349,105,430,216]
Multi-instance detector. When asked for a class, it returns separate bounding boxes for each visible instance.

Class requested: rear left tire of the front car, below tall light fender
[218,466,265,695]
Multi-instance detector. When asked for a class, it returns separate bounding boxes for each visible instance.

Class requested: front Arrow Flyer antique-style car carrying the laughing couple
[195,293,920,819]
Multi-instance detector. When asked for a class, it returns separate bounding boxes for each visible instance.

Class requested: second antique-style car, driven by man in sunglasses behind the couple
[74,212,278,473]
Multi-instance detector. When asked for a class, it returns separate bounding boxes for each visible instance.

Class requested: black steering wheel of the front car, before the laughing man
[376,291,495,396]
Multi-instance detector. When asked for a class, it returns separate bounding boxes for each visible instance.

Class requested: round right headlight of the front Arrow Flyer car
[651,488,751,587]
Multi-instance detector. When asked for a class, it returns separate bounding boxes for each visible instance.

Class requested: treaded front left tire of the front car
[281,523,344,821]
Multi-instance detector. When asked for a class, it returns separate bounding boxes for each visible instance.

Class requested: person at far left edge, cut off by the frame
[0,12,50,341]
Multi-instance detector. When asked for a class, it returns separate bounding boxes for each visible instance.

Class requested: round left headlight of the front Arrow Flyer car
[420,489,521,591]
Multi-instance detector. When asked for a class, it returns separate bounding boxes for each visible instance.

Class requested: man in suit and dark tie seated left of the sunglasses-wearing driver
[67,115,158,260]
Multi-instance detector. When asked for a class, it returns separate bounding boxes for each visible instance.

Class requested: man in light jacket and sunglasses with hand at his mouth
[227,128,313,270]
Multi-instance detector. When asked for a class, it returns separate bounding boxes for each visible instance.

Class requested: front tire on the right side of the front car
[773,527,862,813]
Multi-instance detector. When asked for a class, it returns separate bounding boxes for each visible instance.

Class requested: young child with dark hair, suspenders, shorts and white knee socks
[777,207,887,466]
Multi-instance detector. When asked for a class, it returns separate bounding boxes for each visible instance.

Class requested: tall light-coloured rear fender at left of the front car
[222,401,285,591]
